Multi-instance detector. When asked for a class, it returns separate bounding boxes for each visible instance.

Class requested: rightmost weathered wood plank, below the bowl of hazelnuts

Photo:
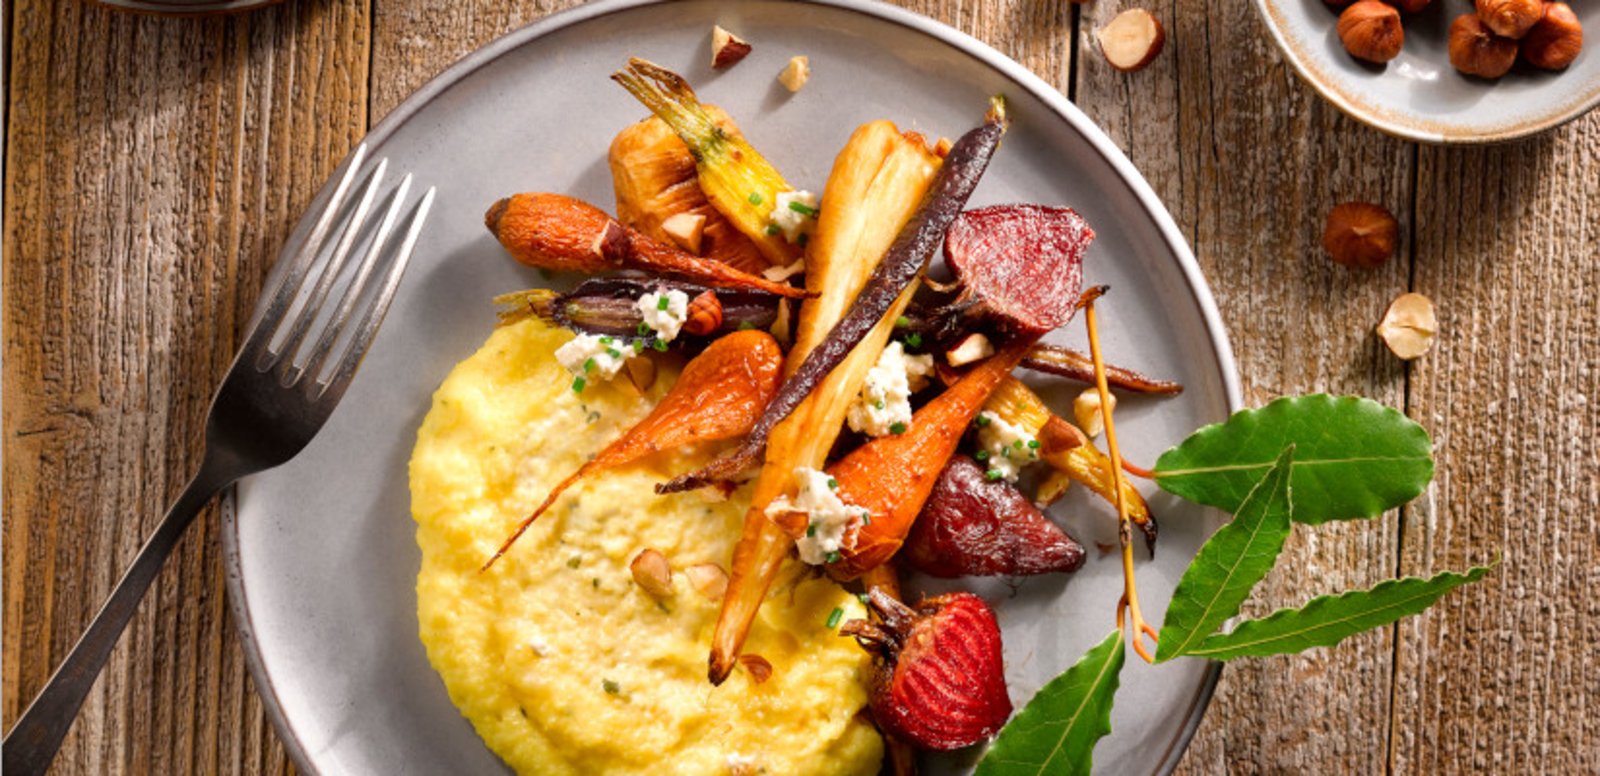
[1390,115,1600,774]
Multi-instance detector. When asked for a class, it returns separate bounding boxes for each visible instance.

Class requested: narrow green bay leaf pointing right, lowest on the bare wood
[1189,562,1499,661]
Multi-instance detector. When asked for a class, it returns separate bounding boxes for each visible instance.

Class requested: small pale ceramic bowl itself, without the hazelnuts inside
[1256,0,1600,144]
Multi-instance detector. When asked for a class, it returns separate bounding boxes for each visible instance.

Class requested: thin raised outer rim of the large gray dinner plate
[221,0,1259,776]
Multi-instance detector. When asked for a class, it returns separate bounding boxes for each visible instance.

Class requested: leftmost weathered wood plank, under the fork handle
[3,2,370,774]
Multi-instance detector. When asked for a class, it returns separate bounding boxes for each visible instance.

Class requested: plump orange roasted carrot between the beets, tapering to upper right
[827,334,1038,579]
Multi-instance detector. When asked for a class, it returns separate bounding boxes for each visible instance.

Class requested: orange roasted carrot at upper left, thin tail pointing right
[483,194,805,296]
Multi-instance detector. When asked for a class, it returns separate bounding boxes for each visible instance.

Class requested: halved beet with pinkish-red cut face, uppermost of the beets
[944,205,1094,334]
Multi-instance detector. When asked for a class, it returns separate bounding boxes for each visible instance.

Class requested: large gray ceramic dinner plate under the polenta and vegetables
[224,2,1240,776]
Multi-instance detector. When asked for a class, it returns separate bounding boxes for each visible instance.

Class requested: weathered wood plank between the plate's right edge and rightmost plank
[1077,0,1414,773]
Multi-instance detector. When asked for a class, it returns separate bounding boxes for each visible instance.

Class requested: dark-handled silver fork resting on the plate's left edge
[3,146,434,776]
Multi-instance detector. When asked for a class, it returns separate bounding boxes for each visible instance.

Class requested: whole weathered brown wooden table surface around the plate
[3,0,1600,774]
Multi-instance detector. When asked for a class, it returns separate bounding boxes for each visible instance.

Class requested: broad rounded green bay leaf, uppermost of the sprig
[1155,394,1434,523]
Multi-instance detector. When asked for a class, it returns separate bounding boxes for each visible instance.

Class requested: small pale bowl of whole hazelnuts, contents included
[1254,0,1600,144]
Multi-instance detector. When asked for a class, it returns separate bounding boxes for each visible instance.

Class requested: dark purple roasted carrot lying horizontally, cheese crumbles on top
[494,277,778,339]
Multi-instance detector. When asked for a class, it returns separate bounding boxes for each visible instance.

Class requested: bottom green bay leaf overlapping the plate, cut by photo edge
[973,630,1126,776]
